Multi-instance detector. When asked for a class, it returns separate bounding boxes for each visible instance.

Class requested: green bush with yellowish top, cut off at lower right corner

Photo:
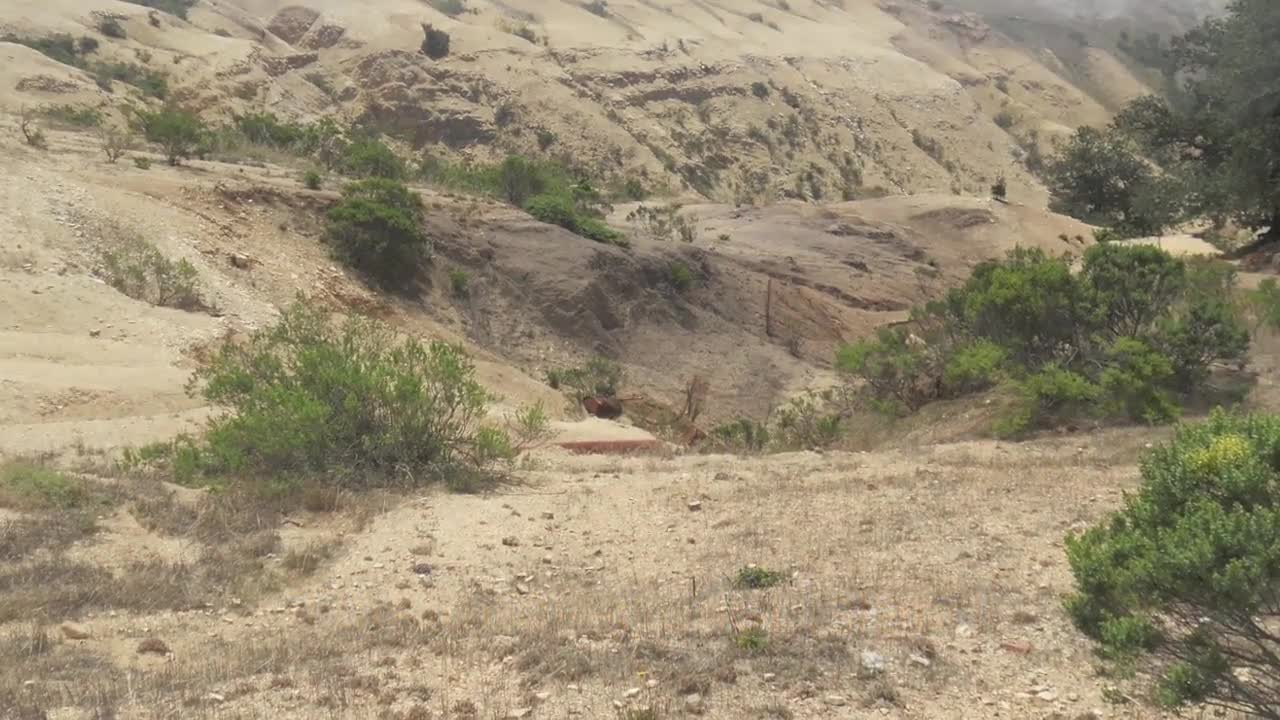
[1066,411,1280,719]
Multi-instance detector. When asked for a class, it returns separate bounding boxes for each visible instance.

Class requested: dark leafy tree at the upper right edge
[1050,0,1280,236]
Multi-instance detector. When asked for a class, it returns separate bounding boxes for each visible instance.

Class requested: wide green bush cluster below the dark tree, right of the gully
[836,243,1249,434]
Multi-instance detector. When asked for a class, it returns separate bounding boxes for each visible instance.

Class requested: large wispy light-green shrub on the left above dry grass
[184,301,511,487]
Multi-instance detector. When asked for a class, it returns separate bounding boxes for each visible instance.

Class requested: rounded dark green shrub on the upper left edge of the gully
[325,178,431,284]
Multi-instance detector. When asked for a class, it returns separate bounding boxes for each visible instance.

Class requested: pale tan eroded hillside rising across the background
[0,0,1162,205]
